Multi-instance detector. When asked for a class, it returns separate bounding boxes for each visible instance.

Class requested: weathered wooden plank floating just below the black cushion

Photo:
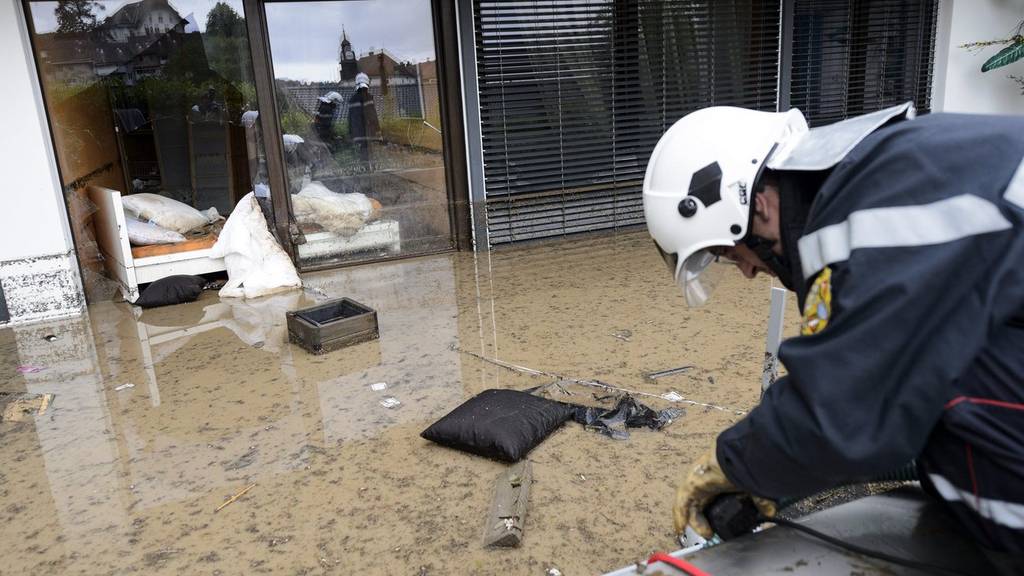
[483,460,534,548]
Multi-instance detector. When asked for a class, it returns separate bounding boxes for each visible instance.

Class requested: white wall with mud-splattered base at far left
[0,0,82,324]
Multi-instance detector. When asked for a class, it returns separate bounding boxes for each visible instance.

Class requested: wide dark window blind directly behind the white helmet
[473,0,780,244]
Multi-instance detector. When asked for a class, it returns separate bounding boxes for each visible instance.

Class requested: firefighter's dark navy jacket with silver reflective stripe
[718,114,1024,552]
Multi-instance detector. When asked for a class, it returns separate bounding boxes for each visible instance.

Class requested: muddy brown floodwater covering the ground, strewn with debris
[0,233,782,576]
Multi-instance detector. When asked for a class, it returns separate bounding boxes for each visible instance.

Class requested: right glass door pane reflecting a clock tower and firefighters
[266,0,452,263]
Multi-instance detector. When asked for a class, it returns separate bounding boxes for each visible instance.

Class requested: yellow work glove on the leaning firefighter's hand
[672,446,775,538]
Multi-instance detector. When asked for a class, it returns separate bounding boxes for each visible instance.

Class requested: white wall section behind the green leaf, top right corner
[932,0,1024,114]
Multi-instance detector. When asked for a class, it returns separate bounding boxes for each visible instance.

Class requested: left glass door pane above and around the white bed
[29,0,269,299]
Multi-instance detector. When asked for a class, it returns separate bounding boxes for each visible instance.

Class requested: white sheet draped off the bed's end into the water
[211,192,302,298]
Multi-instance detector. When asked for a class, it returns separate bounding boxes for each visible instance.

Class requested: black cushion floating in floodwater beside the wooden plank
[420,389,574,462]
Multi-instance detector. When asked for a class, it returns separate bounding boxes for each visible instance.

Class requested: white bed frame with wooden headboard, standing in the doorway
[88,186,226,302]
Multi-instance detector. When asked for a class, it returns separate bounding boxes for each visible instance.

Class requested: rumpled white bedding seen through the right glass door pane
[292,181,374,236]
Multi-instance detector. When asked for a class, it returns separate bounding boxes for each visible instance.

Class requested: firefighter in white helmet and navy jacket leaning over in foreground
[643,102,1024,554]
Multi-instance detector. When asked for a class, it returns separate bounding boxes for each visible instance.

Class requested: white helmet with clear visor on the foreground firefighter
[643,107,808,305]
